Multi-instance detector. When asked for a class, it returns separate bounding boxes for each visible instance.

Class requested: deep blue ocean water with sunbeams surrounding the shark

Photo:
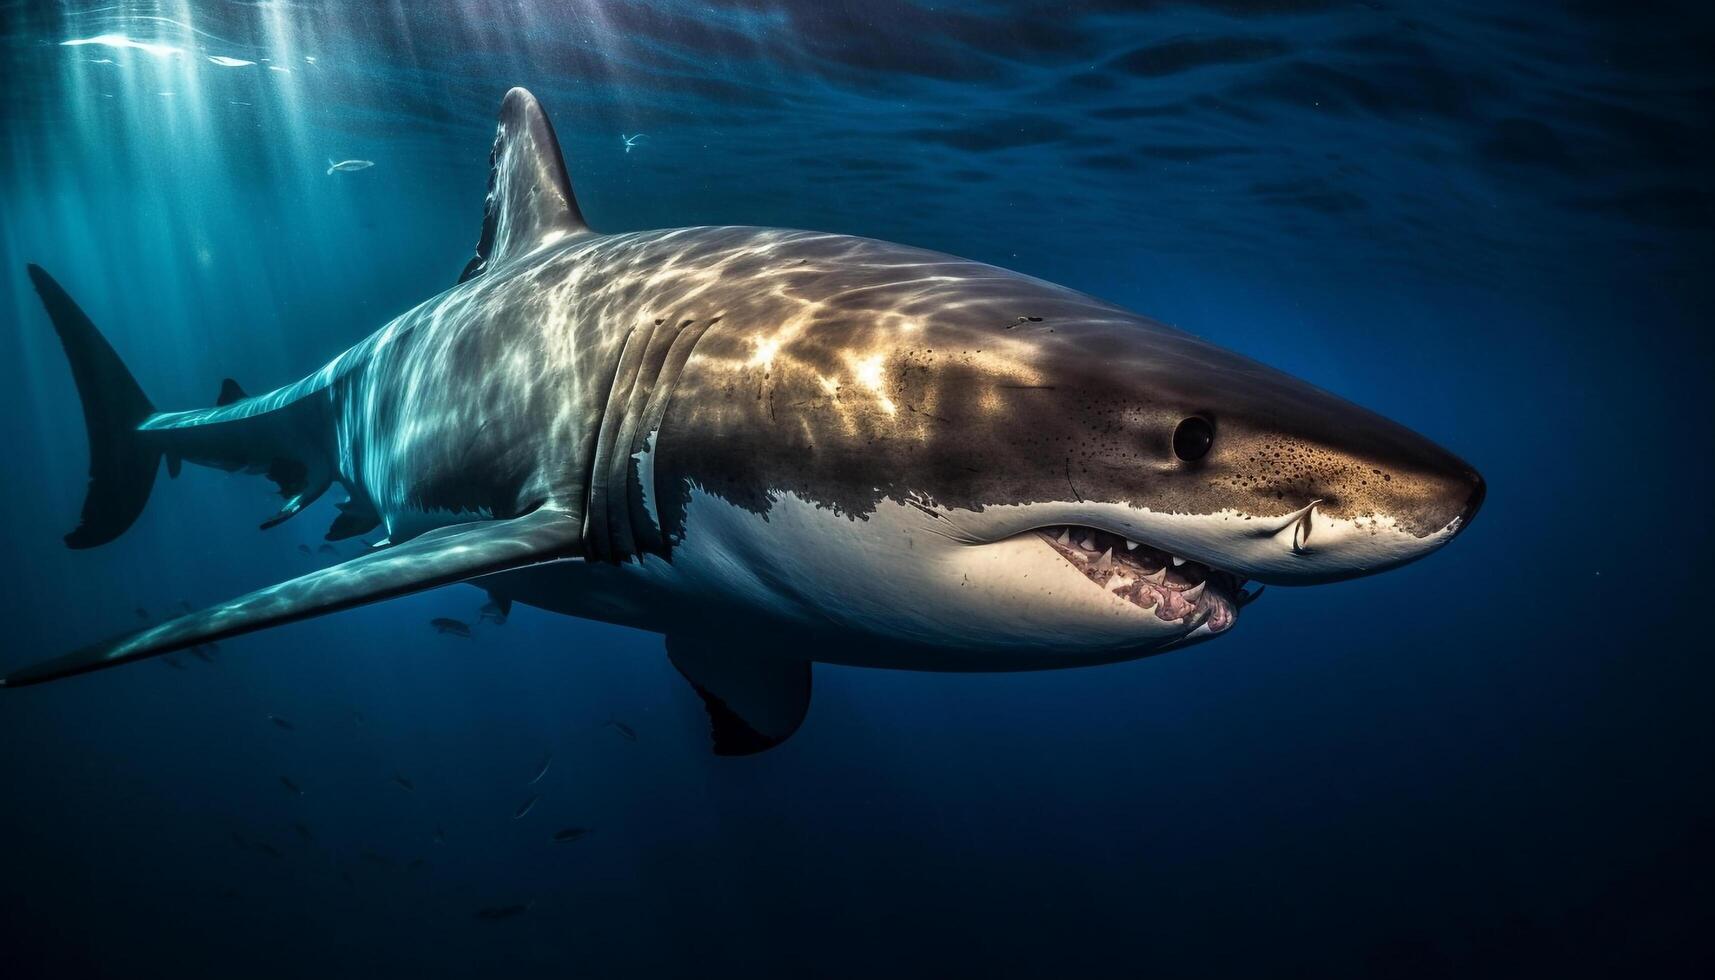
[0,0,1715,977]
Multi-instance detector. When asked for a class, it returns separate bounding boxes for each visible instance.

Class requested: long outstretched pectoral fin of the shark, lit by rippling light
[0,508,583,687]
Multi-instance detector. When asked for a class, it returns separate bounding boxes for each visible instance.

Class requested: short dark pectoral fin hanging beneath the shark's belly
[667,635,809,755]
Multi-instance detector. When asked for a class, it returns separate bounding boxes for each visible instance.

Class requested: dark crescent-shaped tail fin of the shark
[29,266,161,547]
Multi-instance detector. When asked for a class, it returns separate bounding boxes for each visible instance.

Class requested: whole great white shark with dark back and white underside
[0,89,1483,753]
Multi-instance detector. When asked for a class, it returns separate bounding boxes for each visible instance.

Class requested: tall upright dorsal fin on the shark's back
[458,88,590,281]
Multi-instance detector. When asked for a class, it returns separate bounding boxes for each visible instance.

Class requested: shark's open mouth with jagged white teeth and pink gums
[1036,525,1262,633]
